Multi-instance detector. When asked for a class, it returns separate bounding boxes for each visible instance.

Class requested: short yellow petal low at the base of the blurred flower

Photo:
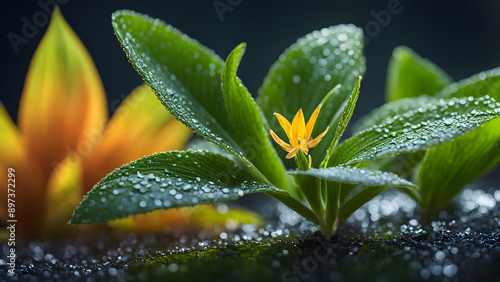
[43,154,83,237]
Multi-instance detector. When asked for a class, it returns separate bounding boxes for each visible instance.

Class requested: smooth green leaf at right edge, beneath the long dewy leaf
[418,118,500,215]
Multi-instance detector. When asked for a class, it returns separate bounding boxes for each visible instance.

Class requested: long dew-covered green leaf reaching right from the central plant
[329,97,500,166]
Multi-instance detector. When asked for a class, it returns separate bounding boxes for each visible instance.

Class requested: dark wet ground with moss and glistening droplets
[0,180,500,282]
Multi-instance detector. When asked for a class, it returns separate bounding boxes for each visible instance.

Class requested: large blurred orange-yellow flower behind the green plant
[0,8,192,238]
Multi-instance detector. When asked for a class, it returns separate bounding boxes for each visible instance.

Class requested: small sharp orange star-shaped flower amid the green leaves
[269,105,329,166]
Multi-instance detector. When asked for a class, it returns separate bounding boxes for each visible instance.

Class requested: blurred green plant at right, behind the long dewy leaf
[357,46,500,216]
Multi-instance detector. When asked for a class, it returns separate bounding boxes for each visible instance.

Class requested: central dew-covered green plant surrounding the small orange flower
[70,11,500,236]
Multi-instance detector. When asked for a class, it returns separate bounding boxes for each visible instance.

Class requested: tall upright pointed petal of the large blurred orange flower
[18,7,107,183]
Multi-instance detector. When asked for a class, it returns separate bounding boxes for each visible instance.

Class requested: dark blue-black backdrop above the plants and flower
[0,0,500,181]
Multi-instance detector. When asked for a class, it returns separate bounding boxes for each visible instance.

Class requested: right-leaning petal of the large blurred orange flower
[84,85,192,191]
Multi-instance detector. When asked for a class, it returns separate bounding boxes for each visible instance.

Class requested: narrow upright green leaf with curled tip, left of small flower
[222,44,290,190]
